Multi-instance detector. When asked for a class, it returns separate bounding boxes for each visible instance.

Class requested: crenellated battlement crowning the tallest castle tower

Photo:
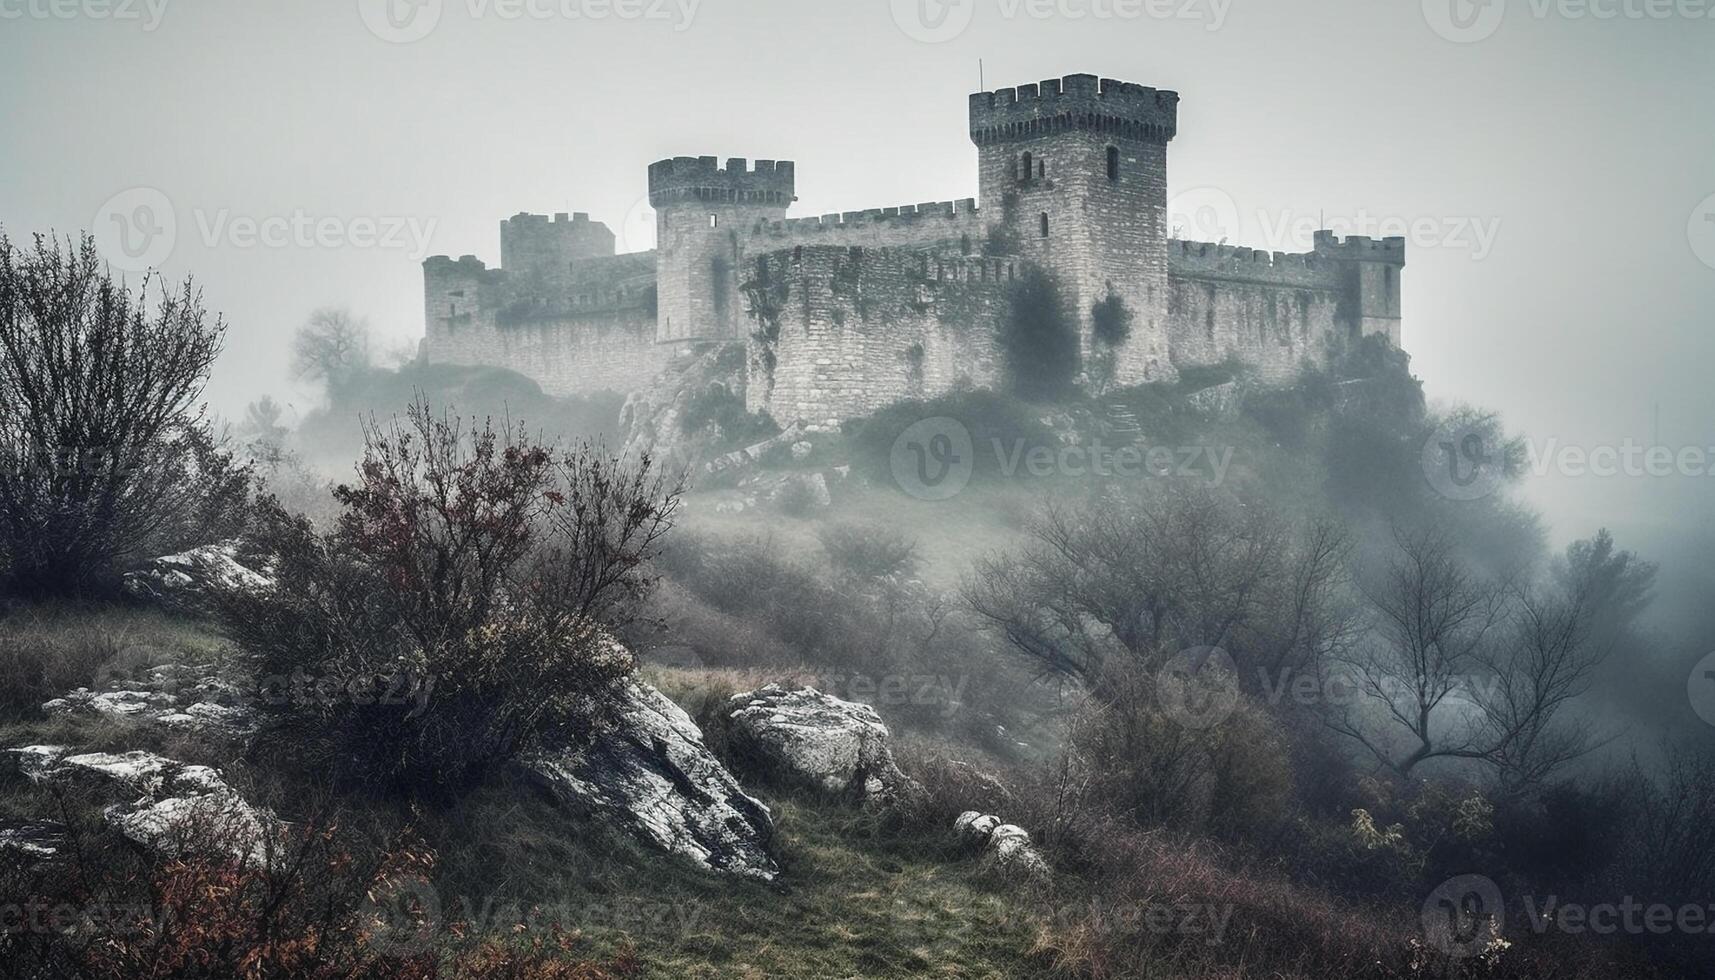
[971,76,1178,146]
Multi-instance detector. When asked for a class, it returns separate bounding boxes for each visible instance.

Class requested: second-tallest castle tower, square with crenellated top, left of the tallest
[648,156,796,343]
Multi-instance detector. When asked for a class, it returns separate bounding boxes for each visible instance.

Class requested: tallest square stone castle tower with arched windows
[971,76,1178,384]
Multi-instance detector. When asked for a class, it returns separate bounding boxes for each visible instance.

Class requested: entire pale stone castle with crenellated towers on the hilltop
[424,76,1405,429]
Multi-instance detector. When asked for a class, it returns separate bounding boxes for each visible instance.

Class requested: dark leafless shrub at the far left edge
[0,235,249,596]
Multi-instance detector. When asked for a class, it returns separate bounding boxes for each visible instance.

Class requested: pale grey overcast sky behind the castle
[0,0,1715,566]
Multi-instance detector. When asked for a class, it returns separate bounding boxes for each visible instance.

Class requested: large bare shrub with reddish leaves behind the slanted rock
[223,403,679,795]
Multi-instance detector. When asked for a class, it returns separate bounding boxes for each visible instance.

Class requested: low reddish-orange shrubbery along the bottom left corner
[0,820,636,980]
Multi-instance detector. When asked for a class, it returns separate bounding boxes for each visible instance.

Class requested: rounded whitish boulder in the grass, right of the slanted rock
[727,685,914,805]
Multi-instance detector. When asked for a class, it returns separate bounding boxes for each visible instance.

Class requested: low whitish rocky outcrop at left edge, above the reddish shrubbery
[7,745,281,865]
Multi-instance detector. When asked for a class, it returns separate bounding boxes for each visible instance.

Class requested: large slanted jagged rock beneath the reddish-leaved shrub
[525,681,780,880]
